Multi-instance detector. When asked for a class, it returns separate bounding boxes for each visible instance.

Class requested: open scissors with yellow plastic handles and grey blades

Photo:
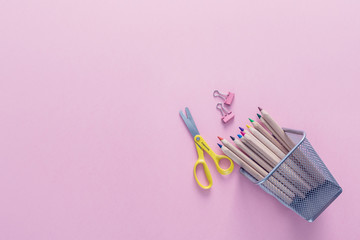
[180,107,234,189]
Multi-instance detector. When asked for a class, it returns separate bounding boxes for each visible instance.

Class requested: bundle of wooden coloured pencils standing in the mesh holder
[218,107,325,204]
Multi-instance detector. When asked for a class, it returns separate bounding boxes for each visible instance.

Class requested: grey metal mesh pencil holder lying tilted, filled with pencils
[240,128,342,222]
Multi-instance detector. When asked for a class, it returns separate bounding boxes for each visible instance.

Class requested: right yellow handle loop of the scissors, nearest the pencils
[194,135,234,175]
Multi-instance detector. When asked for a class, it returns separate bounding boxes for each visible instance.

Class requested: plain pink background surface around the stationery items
[0,0,360,240]
